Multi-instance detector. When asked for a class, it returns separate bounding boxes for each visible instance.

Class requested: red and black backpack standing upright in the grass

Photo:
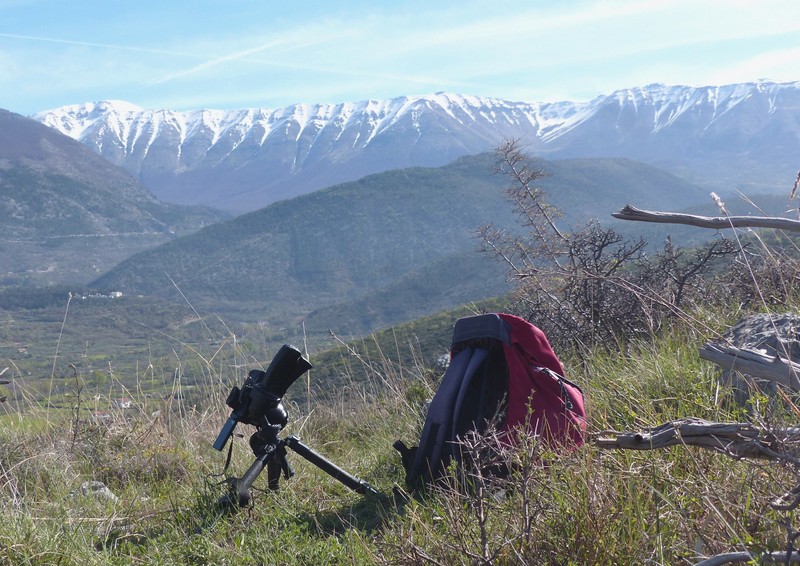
[394,313,586,487]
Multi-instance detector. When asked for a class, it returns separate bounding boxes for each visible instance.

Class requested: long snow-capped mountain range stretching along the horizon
[32,82,800,211]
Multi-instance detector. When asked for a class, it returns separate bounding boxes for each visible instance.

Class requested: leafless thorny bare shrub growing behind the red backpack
[480,140,739,352]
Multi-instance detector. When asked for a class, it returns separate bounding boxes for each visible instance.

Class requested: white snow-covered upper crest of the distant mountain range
[32,81,800,147]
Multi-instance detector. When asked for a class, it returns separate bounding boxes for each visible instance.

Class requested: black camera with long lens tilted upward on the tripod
[214,344,312,450]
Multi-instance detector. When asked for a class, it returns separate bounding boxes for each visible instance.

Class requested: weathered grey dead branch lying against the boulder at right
[700,343,800,391]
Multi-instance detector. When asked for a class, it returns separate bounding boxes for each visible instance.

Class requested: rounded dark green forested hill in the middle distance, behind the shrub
[94,154,716,335]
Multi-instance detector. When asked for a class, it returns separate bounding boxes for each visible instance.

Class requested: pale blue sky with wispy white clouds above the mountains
[0,0,800,115]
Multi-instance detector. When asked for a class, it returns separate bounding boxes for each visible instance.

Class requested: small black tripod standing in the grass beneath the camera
[219,425,378,507]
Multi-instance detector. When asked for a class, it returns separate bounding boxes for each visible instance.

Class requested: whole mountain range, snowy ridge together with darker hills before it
[0,84,798,356]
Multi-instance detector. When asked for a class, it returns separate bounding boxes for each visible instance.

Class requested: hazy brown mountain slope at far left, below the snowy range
[0,110,227,285]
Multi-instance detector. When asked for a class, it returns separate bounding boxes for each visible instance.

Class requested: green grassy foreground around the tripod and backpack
[0,304,797,565]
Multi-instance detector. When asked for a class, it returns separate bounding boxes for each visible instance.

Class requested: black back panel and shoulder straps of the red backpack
[394,315,509,488]
